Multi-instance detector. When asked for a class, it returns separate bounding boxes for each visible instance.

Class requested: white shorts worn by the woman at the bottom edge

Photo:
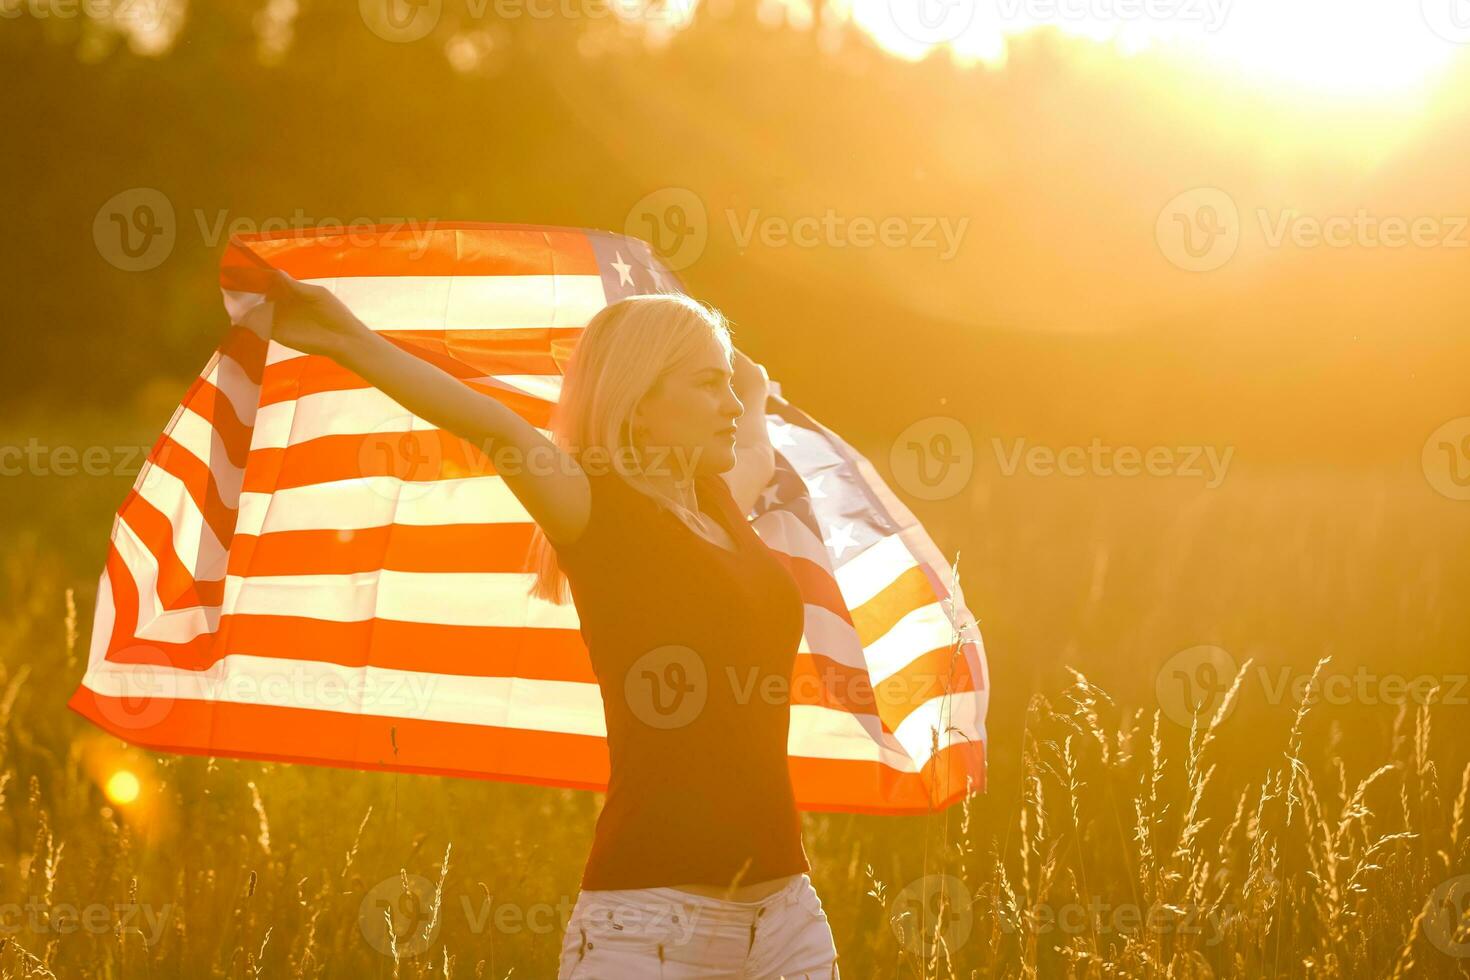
[557,874,842,980]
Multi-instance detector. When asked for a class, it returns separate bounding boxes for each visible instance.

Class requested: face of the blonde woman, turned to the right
[634,336,745,480]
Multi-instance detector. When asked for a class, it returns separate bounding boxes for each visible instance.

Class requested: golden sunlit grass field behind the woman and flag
[0,416,1470,980]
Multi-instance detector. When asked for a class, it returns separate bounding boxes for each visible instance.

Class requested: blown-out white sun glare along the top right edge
[834,0,1470,96]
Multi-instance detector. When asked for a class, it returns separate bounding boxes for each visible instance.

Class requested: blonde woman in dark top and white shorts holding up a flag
[258,272,841,980]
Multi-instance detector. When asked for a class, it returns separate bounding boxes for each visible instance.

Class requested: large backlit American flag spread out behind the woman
[68,222,989,814]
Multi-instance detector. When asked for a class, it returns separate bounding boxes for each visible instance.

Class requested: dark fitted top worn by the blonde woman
[557,467,810,889]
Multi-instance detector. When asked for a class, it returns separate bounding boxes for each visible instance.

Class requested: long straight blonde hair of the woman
[526,292,734,605]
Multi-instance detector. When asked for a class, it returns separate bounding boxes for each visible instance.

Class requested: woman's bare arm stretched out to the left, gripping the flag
[258,264,591,545]
